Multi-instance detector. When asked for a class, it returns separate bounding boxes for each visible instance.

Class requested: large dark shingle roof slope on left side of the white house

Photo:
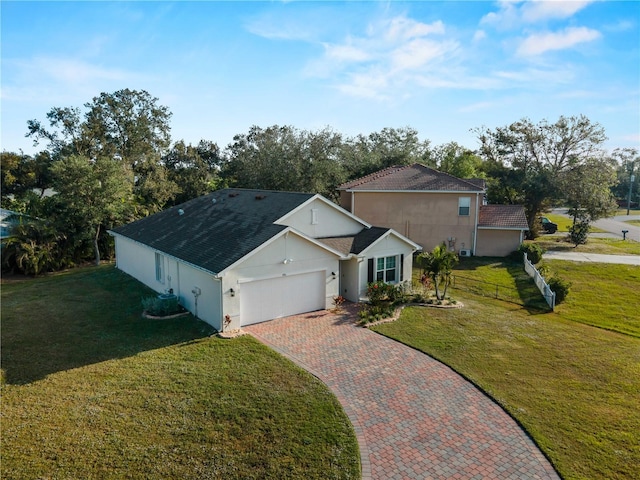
[113,188,314,273]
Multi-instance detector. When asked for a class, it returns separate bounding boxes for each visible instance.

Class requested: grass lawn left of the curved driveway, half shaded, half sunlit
[0,266,360,479]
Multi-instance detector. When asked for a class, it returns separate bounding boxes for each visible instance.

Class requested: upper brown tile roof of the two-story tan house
[338,163,484,192]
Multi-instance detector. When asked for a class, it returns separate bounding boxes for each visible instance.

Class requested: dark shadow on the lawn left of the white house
[0,265,214,384]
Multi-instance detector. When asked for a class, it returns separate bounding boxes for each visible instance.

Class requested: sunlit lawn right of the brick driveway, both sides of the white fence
[374,262,640,479]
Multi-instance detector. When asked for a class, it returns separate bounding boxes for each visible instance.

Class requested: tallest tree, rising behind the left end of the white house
[27,89,178,214]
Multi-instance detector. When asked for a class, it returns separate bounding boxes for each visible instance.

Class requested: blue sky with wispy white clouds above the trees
[0,0,640,153]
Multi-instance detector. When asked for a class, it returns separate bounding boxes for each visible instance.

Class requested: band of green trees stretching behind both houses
[1,89,640,274]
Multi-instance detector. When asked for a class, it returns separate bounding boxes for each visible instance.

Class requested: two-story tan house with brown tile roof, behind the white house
[339,163,528,256]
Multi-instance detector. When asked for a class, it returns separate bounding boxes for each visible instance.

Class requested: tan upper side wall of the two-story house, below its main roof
[344,192,478,251]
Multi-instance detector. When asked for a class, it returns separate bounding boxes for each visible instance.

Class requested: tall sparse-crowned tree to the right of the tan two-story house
[476,115,606,236]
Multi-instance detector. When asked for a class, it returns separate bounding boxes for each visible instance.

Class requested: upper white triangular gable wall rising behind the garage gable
[279,199,364,238]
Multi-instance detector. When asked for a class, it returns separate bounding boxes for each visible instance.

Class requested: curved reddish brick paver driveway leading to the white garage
[245,306,559,480]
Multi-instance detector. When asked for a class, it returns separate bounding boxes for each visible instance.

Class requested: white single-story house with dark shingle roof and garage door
[110,189,419,331]
